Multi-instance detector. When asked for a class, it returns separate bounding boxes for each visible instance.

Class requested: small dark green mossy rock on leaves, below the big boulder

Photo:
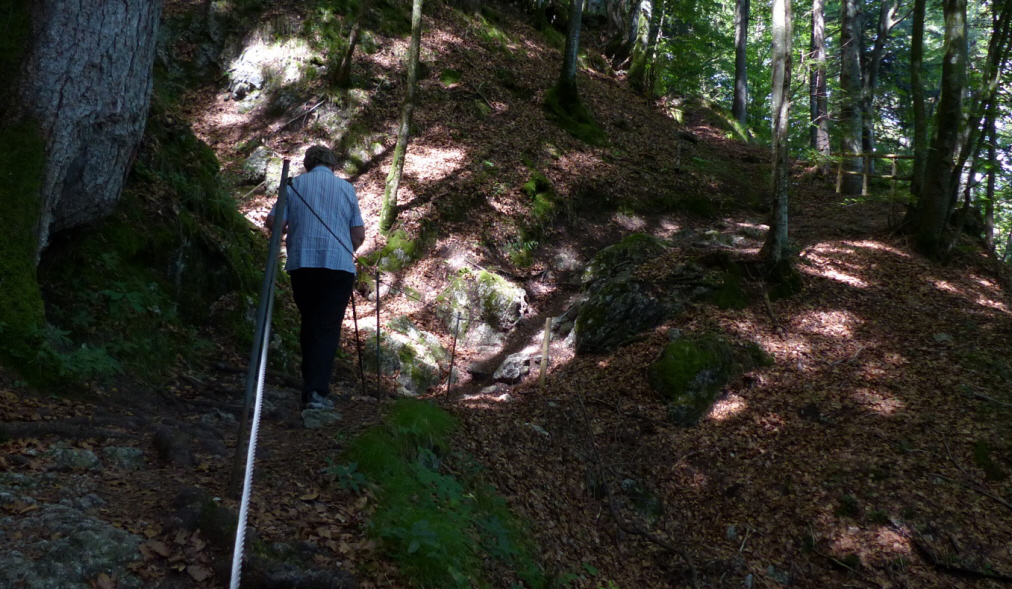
[647,335,768,425]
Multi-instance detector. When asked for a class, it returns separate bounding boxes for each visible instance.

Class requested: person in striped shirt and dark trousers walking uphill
[267,146,365,409]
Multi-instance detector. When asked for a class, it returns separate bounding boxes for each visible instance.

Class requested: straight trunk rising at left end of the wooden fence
[840,0,864,194]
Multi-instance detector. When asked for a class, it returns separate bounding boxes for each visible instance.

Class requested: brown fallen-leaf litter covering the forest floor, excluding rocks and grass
[0,0,1012,589]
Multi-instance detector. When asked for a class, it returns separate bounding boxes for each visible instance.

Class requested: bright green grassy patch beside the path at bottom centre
[340,399,547,588]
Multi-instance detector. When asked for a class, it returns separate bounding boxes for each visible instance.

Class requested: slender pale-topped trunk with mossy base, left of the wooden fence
[761,0,791,264]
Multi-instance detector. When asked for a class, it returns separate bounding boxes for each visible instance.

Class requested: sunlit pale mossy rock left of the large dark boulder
[437,269,527,334]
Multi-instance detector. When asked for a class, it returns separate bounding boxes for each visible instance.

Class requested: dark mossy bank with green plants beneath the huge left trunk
[39,98,297,381]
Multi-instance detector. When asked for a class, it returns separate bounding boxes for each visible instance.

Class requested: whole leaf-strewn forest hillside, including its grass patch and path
[0,2,1012,589]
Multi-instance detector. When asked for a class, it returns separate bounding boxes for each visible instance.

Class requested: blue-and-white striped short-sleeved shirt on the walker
[270,166,364,274]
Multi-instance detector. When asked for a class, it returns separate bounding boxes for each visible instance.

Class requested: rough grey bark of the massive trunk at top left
[17,0,162,263]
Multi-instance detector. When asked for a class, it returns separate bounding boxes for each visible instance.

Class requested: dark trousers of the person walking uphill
[289,268,355,403]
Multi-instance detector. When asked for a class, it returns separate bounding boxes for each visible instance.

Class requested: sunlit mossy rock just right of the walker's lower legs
[362,317,449,395]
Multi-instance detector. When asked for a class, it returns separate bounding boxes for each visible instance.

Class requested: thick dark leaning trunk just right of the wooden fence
[916,0,966,257]
